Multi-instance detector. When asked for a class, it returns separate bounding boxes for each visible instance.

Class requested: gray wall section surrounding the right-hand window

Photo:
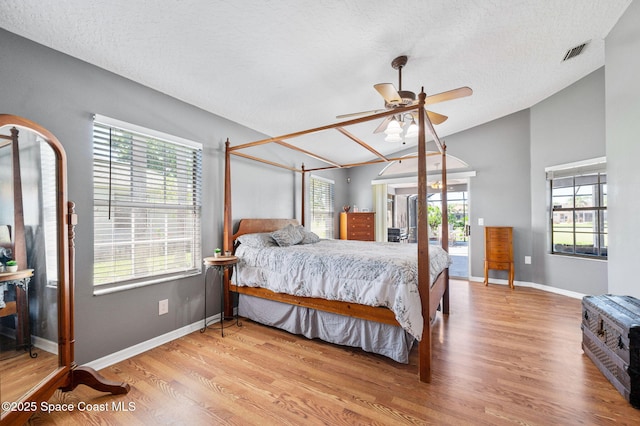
[531,68,611,294]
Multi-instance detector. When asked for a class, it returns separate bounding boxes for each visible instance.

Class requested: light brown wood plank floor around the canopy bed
[30,281,640,425]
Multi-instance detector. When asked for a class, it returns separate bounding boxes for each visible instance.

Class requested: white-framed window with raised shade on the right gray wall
[547,159,609,259]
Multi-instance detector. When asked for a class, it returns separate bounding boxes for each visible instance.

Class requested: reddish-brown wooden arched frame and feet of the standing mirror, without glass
[0,114,130,424]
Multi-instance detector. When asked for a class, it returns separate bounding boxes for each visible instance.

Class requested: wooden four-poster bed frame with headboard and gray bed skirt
[223,88,470,382]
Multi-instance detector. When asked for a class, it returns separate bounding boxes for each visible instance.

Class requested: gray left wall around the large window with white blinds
[0,30,330,364]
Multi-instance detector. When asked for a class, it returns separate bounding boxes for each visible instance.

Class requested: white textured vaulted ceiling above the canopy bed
[0,0,631,163]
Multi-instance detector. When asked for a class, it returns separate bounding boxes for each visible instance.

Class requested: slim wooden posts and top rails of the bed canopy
[223,88,449,382]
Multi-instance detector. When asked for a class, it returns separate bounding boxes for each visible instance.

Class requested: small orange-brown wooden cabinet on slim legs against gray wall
[484,226,515,288]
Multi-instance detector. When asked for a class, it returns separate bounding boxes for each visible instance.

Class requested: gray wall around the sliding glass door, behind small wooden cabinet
[349,111,531,281]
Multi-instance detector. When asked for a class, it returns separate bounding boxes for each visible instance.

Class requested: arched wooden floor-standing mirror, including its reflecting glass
[0,114,129,424]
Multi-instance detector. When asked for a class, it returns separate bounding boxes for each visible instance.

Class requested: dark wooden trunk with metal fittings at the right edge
[581,294,640,408]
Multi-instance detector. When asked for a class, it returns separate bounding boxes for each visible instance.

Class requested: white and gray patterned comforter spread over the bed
[235,240,451,340]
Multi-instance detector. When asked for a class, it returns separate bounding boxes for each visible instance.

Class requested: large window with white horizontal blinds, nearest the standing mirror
[93,116,202,294]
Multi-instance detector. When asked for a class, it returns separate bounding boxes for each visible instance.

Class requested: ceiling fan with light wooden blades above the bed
[336,56,473,137]
